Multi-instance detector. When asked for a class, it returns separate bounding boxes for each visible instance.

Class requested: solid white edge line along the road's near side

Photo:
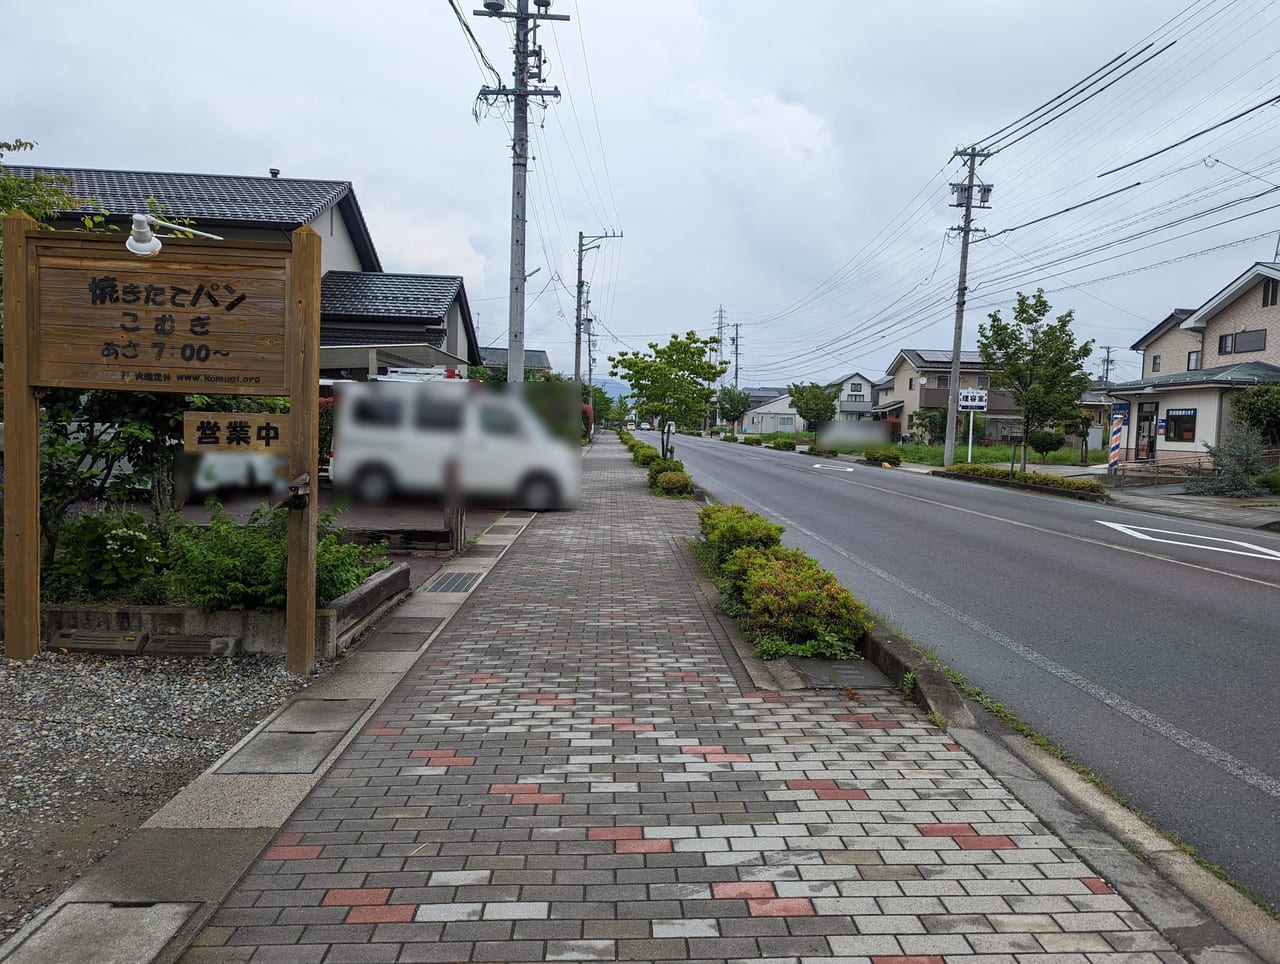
[701,471,1280,798]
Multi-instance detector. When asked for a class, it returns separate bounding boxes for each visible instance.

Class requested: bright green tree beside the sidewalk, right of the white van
[609,332,730,458]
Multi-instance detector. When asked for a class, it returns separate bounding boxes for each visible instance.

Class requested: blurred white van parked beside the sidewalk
[329,379,581,511]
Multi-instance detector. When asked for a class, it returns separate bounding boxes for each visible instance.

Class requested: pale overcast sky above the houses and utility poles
[0,0,1280,385]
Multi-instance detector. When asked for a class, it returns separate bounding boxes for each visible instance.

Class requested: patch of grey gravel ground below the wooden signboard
[0,653,317,941]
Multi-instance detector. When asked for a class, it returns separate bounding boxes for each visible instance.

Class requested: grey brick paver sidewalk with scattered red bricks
[187,439,1180,964]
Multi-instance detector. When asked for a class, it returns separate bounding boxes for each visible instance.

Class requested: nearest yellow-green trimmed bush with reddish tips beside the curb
[741,553,872,650]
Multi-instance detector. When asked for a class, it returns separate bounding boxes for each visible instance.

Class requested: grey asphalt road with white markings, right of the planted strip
[660,433,1280,906]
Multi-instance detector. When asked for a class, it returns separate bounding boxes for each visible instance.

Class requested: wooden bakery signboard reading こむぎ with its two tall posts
[4,213,320,673]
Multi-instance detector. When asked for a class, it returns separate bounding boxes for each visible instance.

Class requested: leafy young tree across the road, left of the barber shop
[978,288,1093,471]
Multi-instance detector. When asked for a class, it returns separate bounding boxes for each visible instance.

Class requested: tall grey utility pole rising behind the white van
[472,0,570,383]
